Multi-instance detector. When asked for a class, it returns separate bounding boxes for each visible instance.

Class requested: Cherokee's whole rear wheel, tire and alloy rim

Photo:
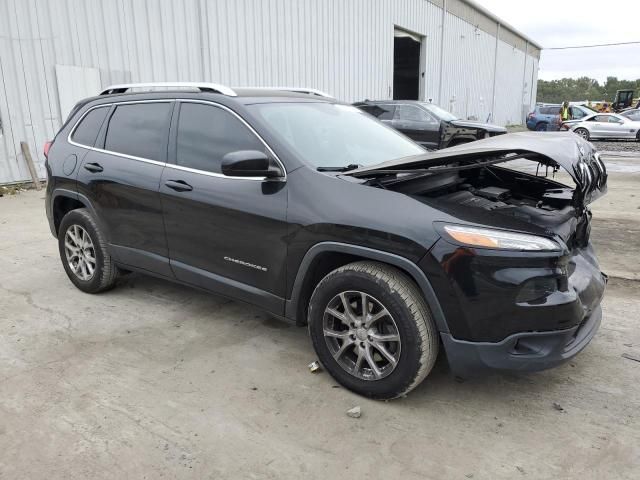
[58,208,118,293]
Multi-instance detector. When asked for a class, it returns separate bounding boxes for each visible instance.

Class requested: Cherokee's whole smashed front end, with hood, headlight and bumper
[348,133,607,376]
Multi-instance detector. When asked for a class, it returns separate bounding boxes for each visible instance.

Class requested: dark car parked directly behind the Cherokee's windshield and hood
[354,100,507,150]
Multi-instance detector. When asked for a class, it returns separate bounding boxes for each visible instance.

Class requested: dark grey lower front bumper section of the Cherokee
[441,305,602,377]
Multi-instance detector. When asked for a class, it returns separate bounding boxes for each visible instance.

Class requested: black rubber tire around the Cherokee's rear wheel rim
[58,208,119,293]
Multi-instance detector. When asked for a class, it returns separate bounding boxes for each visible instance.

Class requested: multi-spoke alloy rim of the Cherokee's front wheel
[322,290,401,381]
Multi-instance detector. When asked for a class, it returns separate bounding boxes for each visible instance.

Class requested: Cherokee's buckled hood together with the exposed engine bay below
[348,133,607,248]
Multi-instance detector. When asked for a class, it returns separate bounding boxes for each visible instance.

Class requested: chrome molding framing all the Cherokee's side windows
[67,98,287,182]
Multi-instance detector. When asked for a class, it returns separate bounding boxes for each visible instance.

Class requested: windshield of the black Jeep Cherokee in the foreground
[248,103,425,168]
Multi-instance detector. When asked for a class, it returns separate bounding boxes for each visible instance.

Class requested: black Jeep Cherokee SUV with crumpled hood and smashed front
[46,84,607,398]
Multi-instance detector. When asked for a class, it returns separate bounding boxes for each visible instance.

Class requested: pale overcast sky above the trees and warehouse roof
[475,0,640,82]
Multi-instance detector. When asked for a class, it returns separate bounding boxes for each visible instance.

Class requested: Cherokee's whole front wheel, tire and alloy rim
[308,261,439,399]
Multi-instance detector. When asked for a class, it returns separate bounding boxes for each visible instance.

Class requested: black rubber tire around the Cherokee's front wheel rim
[308,261,439,399]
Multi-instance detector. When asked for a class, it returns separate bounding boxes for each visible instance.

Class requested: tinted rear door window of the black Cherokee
[104,102,173,162]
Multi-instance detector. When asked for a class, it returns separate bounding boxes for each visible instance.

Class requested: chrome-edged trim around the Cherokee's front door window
[167,98,287,182]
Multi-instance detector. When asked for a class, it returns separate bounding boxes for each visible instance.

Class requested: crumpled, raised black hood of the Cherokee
[346,132,607,206]
